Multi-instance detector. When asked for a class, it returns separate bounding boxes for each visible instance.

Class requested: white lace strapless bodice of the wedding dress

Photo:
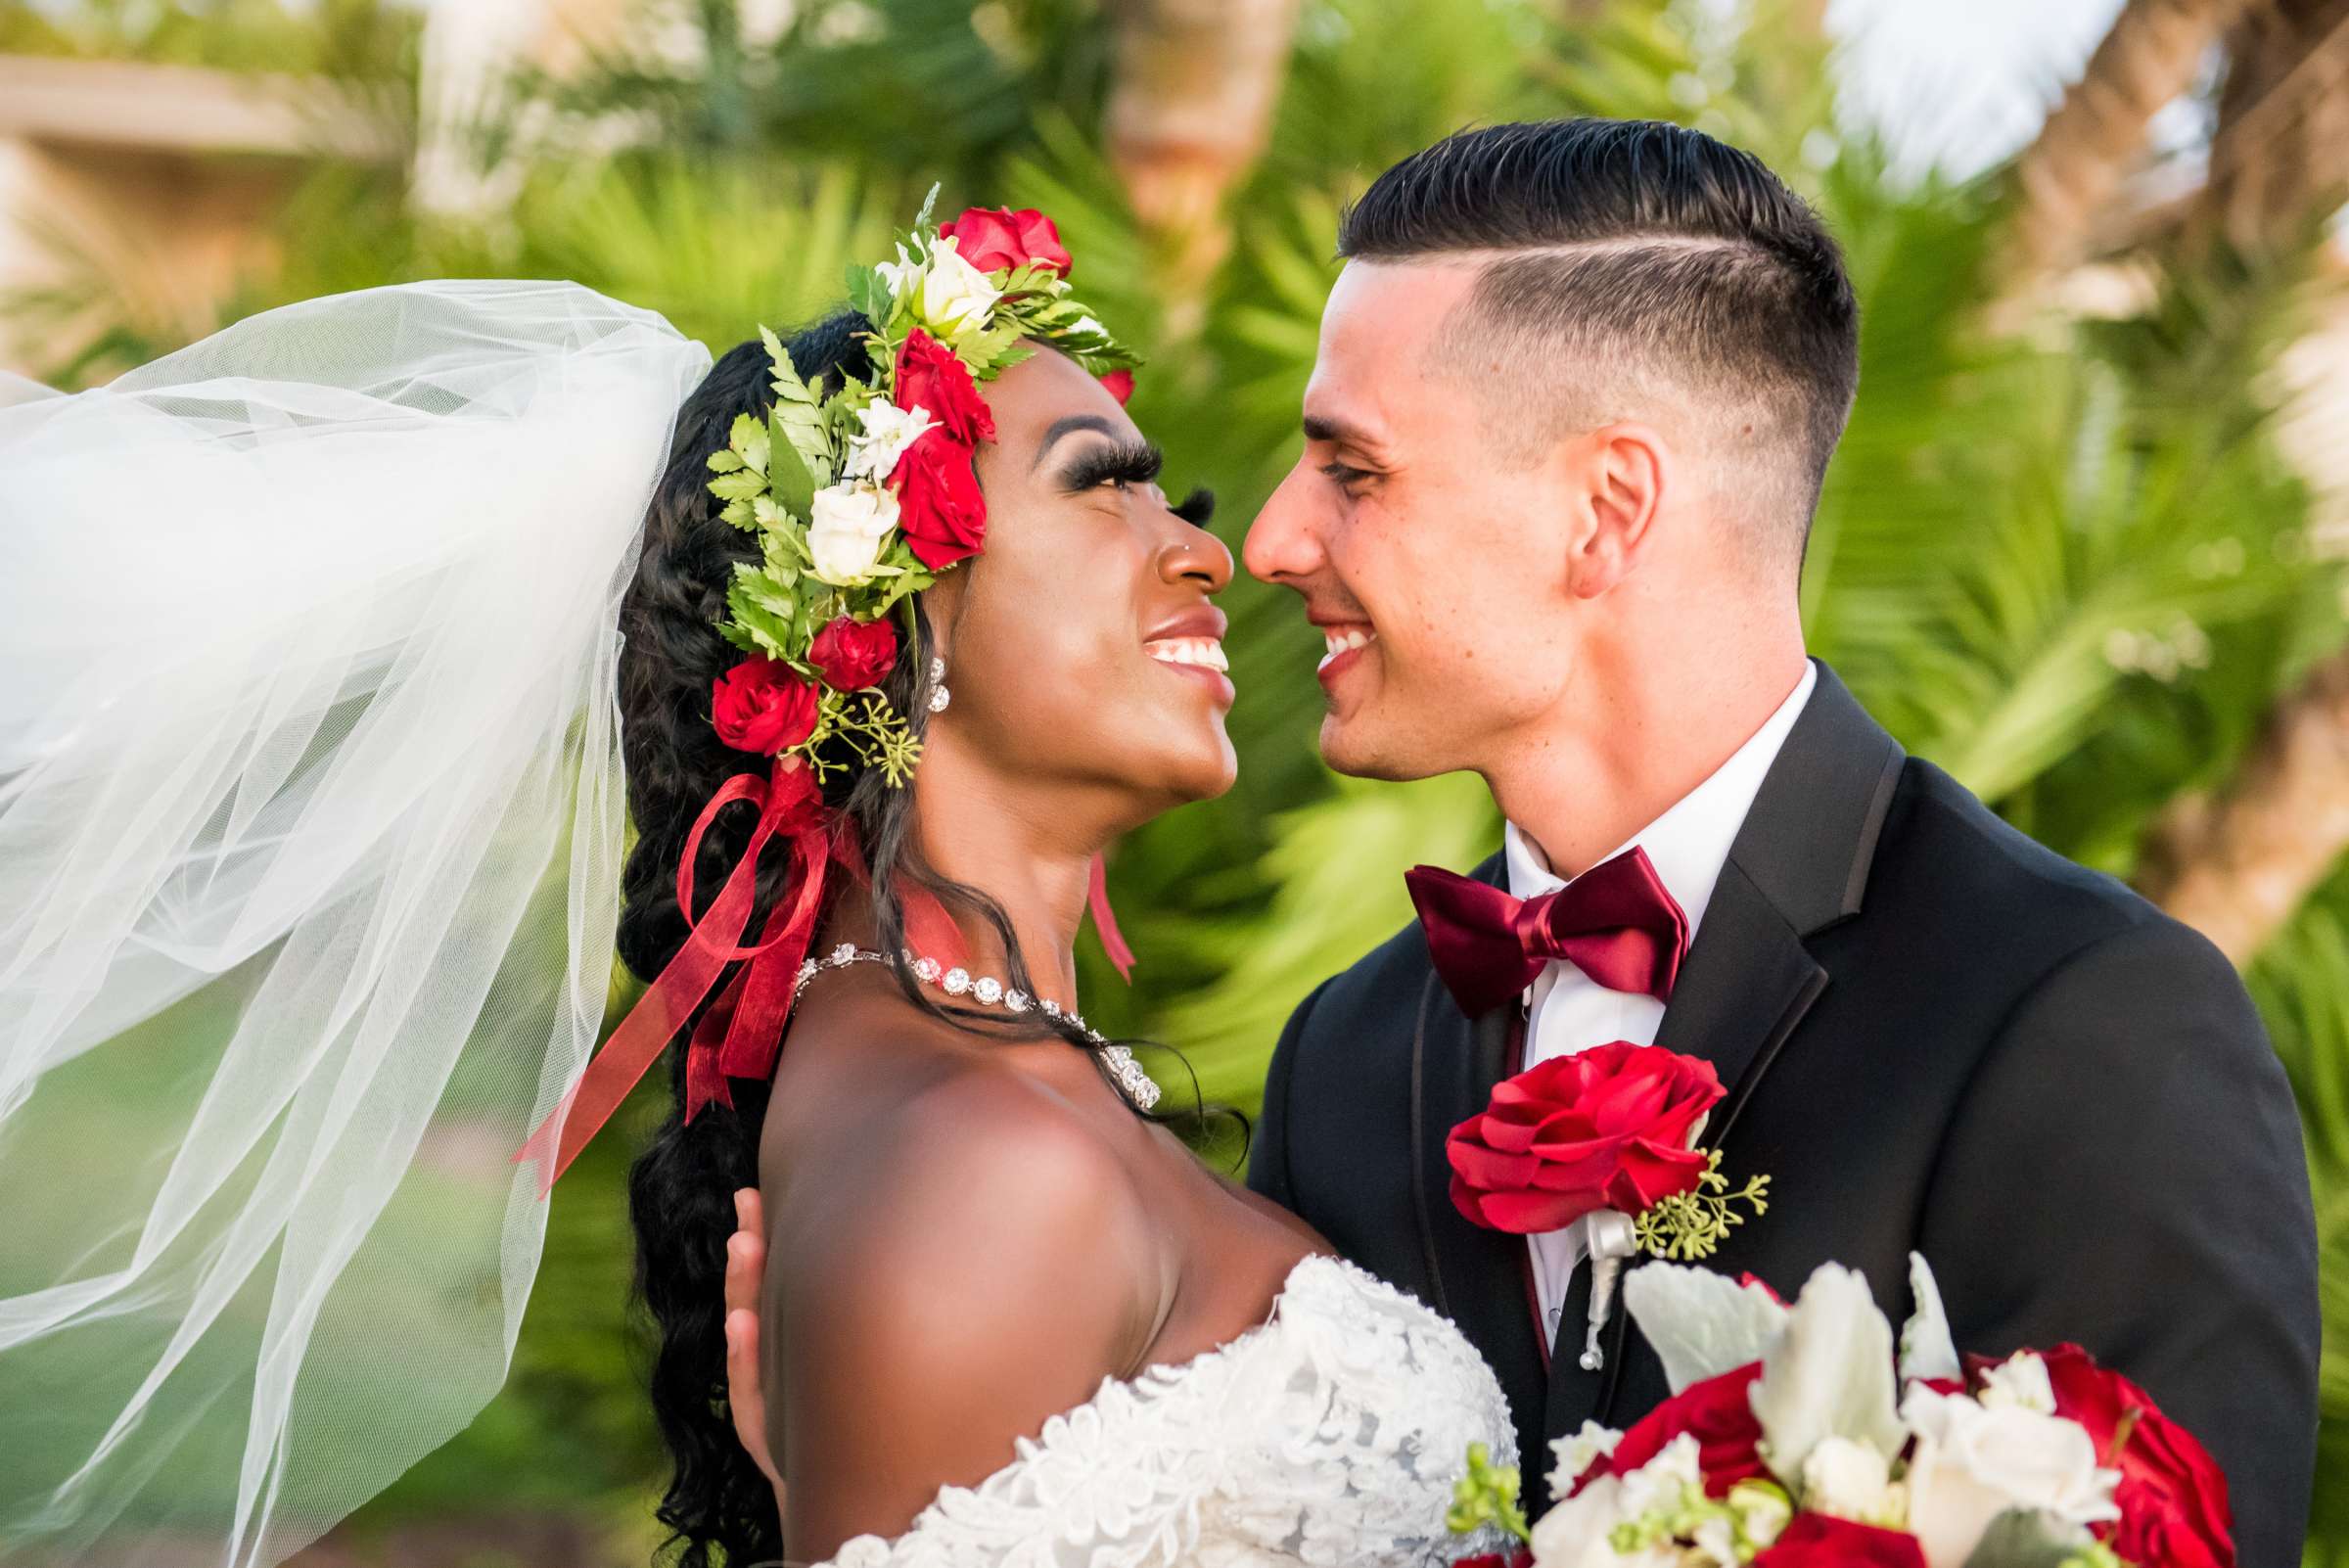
[832,1256,1517,1568]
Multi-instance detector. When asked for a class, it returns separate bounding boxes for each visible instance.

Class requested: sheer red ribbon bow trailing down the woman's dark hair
[515,759,836,1197]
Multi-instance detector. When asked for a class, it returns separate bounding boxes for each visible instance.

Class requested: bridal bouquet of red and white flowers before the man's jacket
[1450,1254,2234,1568]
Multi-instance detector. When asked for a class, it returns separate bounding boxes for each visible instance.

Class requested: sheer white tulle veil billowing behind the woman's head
[0,282,710,1568]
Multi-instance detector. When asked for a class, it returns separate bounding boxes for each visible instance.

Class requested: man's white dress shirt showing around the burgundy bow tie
[1501,660,1819,1345]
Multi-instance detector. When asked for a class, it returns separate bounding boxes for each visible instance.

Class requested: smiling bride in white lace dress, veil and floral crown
[0,199,1513,1566]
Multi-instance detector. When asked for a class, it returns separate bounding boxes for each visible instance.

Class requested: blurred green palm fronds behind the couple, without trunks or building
[0,0,2349,1561]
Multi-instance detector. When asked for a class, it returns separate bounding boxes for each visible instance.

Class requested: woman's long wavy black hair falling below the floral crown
[618,310,1196,1568]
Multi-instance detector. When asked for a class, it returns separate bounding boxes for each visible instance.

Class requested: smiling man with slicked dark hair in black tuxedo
[1245,119,2319,1568]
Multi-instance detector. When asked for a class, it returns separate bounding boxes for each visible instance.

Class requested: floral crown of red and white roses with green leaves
[710,185,1139,784]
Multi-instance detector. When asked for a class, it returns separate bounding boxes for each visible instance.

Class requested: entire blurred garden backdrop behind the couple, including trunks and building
[0,0,2349,1568]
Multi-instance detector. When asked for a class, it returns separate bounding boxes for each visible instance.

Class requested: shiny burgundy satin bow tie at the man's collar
[1403,845,1689,1019]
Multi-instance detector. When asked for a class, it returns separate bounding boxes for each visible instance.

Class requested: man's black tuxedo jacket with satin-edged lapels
[1250,667,2319,1568]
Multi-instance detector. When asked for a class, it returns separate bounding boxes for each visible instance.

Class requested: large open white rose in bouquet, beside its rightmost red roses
[1901,1385,2121,1568]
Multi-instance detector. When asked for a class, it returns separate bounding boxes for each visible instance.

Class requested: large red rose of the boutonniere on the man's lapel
[1445,1039,1722,1234]
